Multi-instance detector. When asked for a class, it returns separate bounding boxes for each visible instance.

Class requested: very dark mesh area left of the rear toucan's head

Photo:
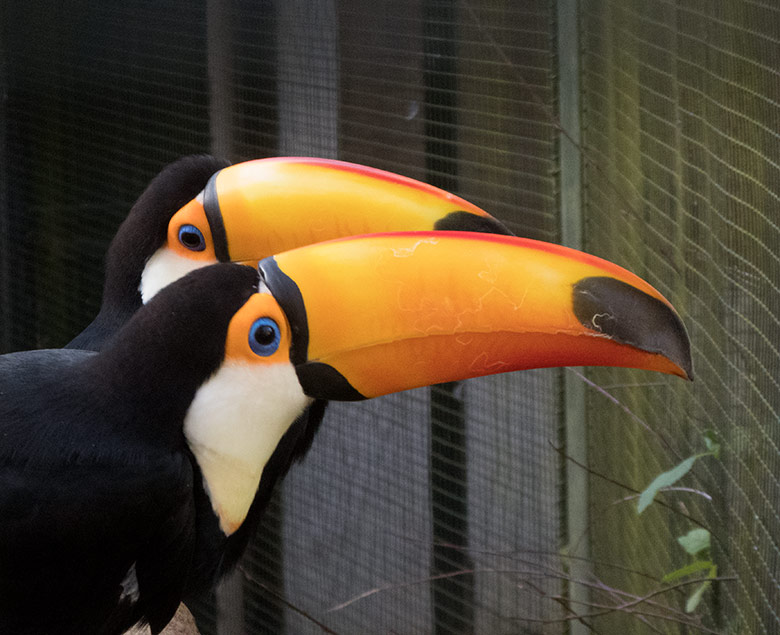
[2,0,213,349]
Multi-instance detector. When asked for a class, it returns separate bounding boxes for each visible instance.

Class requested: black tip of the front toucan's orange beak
[572,277,693,380]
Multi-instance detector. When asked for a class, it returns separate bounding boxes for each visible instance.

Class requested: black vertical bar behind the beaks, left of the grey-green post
[423,0,474,633]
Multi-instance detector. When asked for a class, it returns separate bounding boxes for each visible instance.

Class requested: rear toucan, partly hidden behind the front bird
[66,155,510,350]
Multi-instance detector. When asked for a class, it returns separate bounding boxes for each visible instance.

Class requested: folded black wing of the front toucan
[0,351,194,634]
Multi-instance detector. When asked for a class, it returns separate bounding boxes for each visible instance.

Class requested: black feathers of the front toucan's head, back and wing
[0,265,257,635]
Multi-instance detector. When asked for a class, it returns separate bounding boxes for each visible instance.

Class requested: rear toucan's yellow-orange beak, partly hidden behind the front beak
[202,157,509,266]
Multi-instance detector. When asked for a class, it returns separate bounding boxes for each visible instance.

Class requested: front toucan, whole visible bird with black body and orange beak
[0,231,692,635]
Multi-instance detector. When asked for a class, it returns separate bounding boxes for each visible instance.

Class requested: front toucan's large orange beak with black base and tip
[259,232,692,400]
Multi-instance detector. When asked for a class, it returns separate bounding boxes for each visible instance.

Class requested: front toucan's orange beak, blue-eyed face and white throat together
[180,232,692,534]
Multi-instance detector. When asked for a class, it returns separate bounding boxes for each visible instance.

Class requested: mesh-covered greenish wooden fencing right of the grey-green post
[582,2,780,633]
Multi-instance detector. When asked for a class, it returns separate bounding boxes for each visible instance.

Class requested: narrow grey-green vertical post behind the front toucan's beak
[557,0,590,635]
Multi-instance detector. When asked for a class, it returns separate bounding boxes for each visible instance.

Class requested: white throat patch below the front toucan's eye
[184,362,312,535]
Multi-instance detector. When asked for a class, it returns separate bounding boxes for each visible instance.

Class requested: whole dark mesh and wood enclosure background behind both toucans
[0,0,780,635]
